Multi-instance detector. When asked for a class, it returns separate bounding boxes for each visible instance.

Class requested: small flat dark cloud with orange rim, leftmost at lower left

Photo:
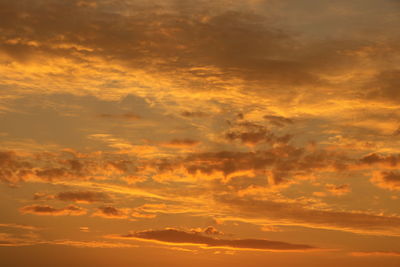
[20,205,87,216]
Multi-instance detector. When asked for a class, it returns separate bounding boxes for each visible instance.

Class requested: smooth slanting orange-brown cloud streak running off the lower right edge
[215,195,400,236]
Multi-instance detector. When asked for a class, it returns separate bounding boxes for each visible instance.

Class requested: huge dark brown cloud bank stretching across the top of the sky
[0,0,376,102]
